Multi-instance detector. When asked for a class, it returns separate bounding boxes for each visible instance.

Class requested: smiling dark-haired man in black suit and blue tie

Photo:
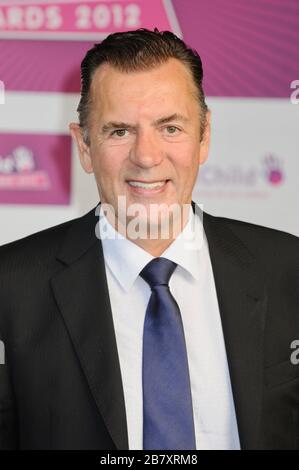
[0,29,299,450]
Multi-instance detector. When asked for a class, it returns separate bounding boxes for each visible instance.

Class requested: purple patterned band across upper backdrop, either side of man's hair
[0,0,299,97]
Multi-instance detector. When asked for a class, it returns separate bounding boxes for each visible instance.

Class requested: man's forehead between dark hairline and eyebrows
[91,58,196,106]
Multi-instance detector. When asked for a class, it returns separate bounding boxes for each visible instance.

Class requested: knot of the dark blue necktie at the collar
[140,257,177,289]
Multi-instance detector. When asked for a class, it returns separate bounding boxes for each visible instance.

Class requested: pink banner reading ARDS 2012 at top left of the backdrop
[0,0,182,40]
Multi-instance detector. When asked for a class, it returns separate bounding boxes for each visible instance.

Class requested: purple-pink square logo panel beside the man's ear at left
[0,134,71,204]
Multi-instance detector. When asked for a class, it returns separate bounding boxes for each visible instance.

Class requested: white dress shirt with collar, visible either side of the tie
[99,205,240,450]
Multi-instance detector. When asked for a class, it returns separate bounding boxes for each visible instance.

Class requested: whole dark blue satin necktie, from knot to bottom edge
[140,257,196,450]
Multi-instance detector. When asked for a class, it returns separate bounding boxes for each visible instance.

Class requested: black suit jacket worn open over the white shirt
[0,202,299,450]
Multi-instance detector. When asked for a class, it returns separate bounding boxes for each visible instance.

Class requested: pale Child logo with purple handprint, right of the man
[198,153,286,198]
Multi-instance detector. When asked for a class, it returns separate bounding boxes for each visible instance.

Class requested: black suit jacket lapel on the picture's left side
[51,204,129,450]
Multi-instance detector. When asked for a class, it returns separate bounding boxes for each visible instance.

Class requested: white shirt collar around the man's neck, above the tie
[99,204,203,292]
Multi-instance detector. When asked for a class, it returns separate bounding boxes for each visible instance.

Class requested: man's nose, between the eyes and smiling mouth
[130,131,163,168]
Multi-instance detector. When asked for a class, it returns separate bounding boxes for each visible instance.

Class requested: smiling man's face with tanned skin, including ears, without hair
[72,59,210,232]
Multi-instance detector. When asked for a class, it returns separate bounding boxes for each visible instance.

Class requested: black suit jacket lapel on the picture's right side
[199,203,267,449]
